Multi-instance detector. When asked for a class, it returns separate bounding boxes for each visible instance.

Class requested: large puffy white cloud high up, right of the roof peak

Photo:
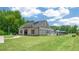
[43,7,70,19]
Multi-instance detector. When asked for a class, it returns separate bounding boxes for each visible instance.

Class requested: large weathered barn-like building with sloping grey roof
[19,21,55,35]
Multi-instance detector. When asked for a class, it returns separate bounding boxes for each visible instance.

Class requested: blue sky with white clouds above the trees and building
[0,7,79,26]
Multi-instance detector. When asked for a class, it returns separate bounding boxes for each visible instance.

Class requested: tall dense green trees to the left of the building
[0,10,25,35]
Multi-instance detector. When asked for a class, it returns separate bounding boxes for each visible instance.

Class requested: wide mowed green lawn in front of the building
[0,35,79,51]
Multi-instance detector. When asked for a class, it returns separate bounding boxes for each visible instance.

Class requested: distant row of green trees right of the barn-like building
[50,25,78,33]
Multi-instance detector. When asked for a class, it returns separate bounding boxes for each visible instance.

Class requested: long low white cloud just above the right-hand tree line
[48,17,79,26]
